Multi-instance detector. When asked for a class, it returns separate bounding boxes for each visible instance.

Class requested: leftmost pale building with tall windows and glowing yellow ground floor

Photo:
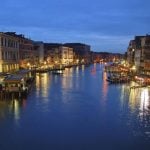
[0,32,19,72]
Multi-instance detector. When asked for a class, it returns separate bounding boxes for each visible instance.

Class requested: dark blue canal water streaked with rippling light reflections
[0,64,150,150]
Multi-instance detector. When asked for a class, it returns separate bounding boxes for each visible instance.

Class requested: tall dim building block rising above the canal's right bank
[127,35,150,74]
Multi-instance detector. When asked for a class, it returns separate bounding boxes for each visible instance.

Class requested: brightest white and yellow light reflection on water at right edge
[129,88,150,138]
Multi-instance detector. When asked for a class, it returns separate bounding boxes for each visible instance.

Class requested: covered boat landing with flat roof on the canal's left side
[0,70,34,100]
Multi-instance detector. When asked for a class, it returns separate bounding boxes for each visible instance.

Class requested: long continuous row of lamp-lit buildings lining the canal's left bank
[0,32,92,72]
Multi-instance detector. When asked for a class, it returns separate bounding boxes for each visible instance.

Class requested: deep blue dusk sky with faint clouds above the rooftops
[0,0,150,53]
